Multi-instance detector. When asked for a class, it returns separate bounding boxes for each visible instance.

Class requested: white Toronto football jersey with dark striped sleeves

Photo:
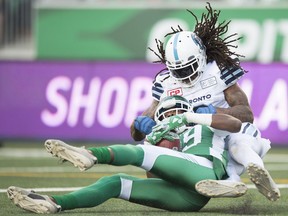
[152,61,244,108]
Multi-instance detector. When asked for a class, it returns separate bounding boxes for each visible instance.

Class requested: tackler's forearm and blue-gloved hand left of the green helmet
[130,100,159,141]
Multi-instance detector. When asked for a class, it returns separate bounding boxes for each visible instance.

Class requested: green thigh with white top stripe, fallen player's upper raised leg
[138,145,218,186]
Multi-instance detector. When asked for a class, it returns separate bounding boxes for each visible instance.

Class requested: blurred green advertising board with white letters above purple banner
[35,4,288,63]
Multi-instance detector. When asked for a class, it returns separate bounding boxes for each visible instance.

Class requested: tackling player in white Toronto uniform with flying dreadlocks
[131,3,280,200]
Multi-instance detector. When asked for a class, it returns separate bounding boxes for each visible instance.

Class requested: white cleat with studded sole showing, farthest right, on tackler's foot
[247,163,281,201]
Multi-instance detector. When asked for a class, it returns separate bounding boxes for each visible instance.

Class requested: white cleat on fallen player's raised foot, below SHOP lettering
[44,140,97,171]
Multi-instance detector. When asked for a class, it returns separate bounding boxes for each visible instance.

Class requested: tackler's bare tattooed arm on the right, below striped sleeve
[215,83,254,123]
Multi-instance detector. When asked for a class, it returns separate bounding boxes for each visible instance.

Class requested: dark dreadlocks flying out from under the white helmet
[148,2,247,72]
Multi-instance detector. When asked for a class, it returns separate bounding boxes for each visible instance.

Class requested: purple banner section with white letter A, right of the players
[239,63,288,145]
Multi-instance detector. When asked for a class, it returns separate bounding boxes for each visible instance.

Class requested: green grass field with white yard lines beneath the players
[0,143,288,216]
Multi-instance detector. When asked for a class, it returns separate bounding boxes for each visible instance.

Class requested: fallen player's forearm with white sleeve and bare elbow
[183,112,242,133]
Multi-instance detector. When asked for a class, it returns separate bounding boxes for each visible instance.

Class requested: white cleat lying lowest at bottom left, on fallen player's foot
[7,186,61,214]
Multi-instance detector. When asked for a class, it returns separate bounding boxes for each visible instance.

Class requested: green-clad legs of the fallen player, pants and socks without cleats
[53,145,216,211]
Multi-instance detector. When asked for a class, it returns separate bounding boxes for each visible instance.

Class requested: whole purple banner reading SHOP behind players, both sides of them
[0,61,288,144]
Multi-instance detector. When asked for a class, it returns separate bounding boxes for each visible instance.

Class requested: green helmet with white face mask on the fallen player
[154,95,193,123]
